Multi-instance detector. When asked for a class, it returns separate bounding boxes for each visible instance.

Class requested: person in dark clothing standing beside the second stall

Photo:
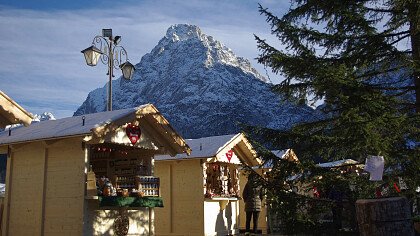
[242,173,263,234]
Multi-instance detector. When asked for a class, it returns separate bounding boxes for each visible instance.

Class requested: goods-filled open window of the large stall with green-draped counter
[90,144,160,197]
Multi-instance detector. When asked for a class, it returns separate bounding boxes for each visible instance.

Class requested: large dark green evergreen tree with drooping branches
[256,0,420,167]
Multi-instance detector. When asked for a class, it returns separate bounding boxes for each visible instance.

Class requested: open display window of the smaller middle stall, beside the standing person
[205,162,239,198]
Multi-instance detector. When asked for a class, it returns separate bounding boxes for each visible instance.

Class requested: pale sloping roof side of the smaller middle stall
[155,133,241,161]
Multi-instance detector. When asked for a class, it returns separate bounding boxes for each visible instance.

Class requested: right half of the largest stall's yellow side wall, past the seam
[44,139,85,236]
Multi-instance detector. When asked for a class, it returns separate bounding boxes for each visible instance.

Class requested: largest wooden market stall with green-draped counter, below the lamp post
[0,104,190,235]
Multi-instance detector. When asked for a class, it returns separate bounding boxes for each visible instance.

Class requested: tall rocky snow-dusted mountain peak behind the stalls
[74,24,314,138]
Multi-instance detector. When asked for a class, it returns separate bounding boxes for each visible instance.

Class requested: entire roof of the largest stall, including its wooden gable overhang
[0,104,191,156]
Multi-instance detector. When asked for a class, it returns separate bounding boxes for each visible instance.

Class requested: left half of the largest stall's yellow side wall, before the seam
[4,143,45,236]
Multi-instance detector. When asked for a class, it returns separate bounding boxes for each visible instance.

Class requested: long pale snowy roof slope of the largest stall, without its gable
[0,104,150,145]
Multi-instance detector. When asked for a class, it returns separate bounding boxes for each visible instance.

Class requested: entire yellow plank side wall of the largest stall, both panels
[3,138,85,236]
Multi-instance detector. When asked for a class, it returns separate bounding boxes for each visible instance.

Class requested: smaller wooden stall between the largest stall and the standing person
[155,134,260,235]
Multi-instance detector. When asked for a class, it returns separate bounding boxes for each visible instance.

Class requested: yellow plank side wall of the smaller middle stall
[155,159,204,235]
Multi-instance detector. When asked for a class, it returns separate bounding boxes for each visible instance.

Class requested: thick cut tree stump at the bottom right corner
[356,197,414,236]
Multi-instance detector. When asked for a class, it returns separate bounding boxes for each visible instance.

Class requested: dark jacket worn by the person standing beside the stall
[242,181,264,211]
